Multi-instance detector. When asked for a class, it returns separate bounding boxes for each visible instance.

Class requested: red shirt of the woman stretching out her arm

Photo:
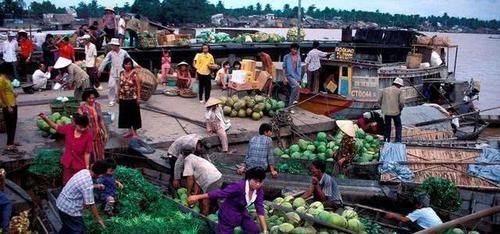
[57,124,93,171]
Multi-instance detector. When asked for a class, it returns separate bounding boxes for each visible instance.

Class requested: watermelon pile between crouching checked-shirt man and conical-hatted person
[274,132,342,161]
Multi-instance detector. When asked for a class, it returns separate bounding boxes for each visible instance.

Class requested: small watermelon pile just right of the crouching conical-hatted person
[354,129,380,163]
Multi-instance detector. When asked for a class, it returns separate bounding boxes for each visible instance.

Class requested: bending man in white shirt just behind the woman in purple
[178,146,223,216]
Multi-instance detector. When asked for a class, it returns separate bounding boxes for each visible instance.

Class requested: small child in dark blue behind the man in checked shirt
[96,159,123,216]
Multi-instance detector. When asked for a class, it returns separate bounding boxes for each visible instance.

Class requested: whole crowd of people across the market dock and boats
[0,8,454,233]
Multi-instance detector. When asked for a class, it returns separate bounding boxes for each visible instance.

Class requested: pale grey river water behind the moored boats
[197,28,500,114]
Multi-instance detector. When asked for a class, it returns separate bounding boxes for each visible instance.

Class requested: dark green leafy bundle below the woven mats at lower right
[416,177,462,211]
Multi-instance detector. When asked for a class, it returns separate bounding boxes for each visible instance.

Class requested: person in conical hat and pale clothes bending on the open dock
[205,98,231,153]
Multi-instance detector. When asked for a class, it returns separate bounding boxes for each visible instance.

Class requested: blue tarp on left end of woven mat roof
[379,143,414,182]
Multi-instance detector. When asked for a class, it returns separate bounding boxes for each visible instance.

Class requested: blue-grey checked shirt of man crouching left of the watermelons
[245,135,274,169]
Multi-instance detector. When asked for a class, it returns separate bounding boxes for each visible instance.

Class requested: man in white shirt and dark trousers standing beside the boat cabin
[305,41,328,92]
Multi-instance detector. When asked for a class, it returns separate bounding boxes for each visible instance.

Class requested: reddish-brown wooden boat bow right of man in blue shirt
[297,89,352,116]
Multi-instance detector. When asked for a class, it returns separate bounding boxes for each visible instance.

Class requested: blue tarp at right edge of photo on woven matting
[468,147,500,183]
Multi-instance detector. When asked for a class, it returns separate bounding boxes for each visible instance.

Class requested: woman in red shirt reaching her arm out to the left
[39,113,93,185]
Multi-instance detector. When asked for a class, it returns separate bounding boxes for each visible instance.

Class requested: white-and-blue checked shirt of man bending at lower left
[56,169,94,217]
